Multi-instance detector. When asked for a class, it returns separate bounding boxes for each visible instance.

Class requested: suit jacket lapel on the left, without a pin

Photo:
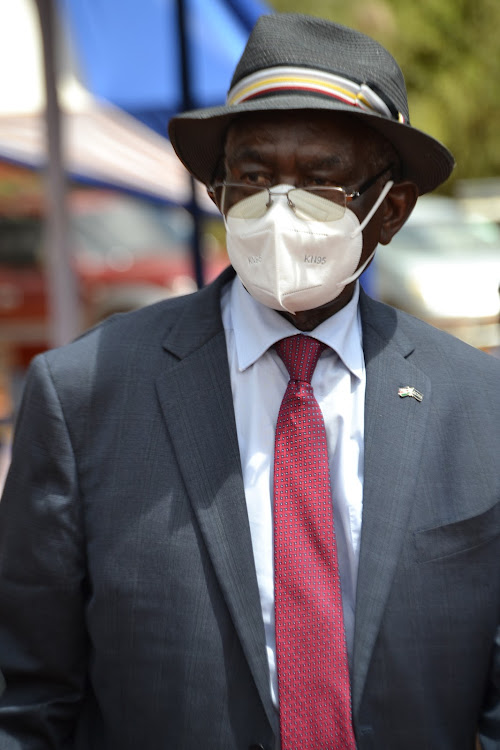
[157,275,276,736]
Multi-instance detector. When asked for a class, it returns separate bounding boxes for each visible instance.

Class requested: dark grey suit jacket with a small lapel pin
[0,268,500,750]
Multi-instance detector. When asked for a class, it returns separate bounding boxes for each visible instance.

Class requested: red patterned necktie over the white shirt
[274,335,356,750]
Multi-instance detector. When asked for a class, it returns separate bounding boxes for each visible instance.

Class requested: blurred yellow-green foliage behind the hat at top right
[264,0,500,190]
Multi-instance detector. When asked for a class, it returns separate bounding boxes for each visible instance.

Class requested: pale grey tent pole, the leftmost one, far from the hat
[36,0,81,346]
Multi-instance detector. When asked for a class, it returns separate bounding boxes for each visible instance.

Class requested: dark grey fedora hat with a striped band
[169,13,454,194]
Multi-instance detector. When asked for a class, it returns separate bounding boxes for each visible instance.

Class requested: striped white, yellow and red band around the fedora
[227,66,404,122]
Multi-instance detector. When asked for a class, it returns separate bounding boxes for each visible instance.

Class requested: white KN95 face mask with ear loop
[225,181,393,313]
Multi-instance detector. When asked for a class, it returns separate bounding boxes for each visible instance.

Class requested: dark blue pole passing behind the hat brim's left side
[177,0,204,288]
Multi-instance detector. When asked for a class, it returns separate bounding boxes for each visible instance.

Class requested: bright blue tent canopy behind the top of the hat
[58,0,269,135]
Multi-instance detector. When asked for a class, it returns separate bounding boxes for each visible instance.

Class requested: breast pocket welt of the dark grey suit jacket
[414,502,500,562]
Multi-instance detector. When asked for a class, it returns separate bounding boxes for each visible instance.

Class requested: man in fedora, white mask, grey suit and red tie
[0,14,500,750]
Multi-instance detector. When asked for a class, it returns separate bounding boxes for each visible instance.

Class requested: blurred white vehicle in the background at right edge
[374,196,500,353]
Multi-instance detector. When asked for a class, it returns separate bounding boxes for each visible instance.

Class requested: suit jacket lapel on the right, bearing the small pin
[353,298,430,717]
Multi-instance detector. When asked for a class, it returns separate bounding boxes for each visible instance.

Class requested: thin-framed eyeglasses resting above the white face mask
[209,164,393,221]
